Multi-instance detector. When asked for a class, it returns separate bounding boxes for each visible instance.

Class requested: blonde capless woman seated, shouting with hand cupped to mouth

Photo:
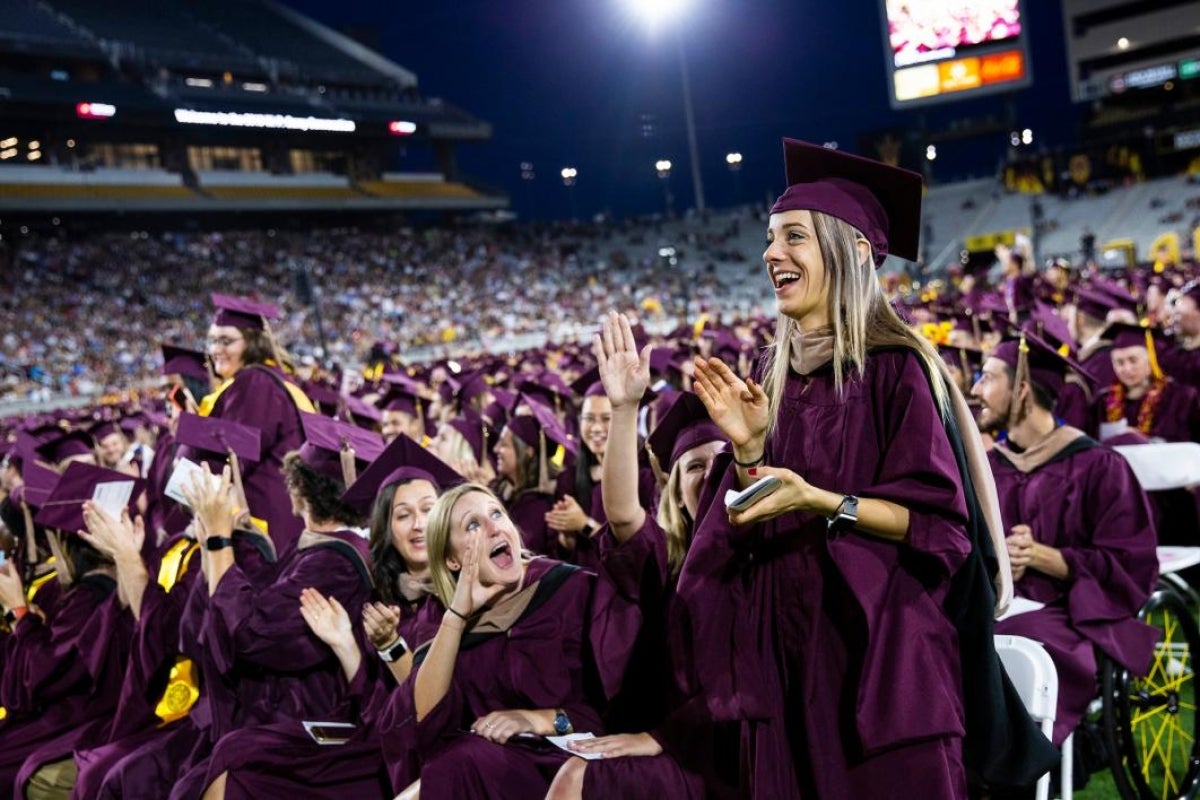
[380,483,632,800]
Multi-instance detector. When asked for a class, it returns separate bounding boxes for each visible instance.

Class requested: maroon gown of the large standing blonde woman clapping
[678,350,971,800]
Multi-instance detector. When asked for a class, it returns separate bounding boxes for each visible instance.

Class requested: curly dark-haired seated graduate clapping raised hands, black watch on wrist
[182,414,385,800]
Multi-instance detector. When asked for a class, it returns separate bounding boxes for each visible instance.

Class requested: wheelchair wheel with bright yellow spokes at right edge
[1100,590,1200,800]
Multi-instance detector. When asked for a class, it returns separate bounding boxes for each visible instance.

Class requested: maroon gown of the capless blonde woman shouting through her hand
[380,559,628,800]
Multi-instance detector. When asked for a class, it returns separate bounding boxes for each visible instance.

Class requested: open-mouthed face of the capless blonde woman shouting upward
[445,492,524,587]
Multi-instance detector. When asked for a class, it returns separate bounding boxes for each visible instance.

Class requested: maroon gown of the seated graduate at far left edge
[0,575,133,798]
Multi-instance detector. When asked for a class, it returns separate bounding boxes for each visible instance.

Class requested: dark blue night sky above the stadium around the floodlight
[278,0,1078,217]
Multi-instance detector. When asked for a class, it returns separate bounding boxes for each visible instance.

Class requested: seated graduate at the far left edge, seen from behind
[0,463,142,798]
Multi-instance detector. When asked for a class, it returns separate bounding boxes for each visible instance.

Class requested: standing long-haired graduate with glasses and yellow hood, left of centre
[180,295,314,559]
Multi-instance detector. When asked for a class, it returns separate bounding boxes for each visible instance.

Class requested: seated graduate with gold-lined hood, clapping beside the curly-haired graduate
[72,414,275,800]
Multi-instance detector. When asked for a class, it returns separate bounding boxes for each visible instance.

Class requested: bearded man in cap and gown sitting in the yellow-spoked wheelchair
[971,333,1158,745]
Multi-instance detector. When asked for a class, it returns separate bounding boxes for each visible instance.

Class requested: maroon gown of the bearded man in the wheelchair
[988,432,1158,744]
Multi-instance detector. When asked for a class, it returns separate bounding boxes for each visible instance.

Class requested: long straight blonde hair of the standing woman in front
[763,211,949,437]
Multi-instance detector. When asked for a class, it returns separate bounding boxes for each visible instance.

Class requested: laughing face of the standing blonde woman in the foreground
[762,211,829,330]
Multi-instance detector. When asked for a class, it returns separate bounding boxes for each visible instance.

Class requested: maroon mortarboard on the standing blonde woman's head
[770,139,922,266]
